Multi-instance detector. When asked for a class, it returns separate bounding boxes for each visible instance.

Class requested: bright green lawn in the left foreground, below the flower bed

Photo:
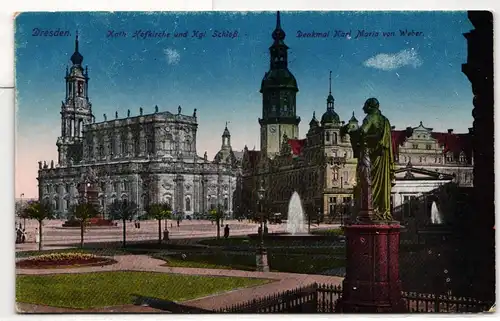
[16,272,269,309]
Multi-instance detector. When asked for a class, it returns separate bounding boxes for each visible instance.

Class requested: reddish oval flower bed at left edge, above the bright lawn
[16,252,116,269]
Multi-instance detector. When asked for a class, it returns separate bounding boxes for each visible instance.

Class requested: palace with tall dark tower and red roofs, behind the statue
[238,12,473,220]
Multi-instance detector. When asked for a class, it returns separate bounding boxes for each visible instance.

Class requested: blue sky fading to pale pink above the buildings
[15,12,472,196]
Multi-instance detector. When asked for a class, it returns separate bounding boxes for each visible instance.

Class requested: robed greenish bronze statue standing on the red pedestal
[341,98,394,221]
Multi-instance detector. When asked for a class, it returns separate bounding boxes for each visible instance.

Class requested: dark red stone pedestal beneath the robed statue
[339,222,406,313]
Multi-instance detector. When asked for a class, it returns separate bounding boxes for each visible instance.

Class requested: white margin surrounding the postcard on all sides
[0,0,500,320]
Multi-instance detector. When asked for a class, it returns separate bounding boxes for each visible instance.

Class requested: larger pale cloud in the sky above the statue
[363,48,423,71]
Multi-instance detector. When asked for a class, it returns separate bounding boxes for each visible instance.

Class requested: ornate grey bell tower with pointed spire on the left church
[57,32,93,167]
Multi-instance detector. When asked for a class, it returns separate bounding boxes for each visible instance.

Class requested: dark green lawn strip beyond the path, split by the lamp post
[154,251,345,274]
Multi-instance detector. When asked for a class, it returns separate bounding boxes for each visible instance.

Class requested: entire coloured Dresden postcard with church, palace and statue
[15,11,495,313]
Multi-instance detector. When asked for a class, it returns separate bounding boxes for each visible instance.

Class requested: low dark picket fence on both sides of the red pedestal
[215,283,492,313]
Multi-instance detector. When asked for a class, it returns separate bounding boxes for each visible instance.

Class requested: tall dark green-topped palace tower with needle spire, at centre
[259,11,300,158]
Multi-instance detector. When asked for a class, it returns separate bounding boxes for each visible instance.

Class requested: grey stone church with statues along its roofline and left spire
[37,35,241,217]
